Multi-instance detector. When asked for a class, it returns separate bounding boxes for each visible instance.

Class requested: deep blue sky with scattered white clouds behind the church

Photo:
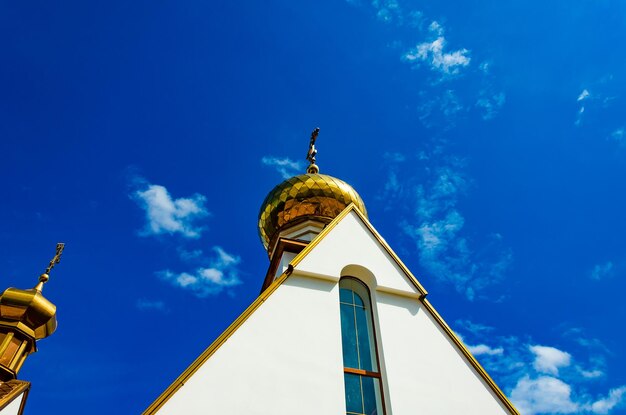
[0,0,626,415]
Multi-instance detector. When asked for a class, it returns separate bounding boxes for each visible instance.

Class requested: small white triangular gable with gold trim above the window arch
[291,204,427,298]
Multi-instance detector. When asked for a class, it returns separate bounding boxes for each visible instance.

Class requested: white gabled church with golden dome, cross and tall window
[144,130,518,415]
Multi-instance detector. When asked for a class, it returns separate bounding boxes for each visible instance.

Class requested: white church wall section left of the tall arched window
[154,275,345,415]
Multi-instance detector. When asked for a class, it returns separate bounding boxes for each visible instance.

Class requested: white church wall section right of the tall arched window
[376,292,509,415]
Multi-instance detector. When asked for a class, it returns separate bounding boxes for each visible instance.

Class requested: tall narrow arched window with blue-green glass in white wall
[339,277,384,415]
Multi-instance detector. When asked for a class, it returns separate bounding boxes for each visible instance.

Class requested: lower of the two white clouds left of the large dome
[157,246,241,298]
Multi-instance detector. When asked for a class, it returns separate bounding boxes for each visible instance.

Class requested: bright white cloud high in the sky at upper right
[403,21,471,75]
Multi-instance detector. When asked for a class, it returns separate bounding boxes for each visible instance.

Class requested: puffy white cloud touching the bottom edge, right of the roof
[511,376,580,415]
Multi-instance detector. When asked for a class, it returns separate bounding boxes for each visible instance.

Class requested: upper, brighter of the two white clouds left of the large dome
[131,184,209,238]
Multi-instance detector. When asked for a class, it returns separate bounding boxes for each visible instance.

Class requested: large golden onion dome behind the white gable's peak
[259,173,367,249]
